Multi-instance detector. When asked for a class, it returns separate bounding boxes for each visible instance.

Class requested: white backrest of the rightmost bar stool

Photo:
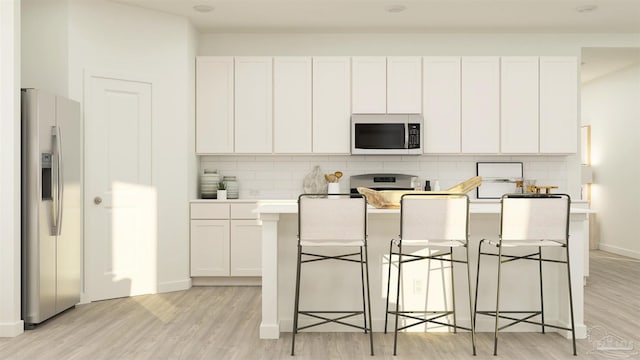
[500,194,571,242]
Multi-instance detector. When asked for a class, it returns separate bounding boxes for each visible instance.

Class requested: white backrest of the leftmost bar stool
[298,194,367,246]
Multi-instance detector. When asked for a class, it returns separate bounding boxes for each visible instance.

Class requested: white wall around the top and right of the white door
[68,0,196,292]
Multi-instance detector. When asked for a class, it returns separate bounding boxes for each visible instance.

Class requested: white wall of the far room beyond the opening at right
[582,64,640,259]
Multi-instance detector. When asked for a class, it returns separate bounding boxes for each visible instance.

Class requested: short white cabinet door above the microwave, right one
[387,56,422,114]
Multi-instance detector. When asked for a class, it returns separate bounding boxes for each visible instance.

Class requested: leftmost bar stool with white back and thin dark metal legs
[291,194,373,355]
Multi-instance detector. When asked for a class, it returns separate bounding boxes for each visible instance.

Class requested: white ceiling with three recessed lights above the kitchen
[113,0,640,33]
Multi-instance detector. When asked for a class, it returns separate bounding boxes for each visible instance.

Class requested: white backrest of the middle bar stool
[400,194,469,241]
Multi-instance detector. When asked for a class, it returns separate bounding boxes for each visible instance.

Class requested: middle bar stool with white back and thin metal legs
[384,193,476,355]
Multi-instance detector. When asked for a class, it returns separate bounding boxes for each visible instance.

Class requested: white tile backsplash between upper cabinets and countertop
[198,155,568,199]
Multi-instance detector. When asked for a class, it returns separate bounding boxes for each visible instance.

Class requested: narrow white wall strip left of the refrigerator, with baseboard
[0,0,24,337]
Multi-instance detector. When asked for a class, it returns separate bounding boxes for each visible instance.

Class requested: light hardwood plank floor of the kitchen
[0,251,640,360]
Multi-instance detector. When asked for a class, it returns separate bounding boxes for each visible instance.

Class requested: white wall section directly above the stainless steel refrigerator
[21,0,69,96]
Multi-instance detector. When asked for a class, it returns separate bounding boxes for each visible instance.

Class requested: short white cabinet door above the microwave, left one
[351,56,387,114]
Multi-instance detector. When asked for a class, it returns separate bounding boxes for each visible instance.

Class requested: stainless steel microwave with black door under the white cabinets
[351,114,423,155]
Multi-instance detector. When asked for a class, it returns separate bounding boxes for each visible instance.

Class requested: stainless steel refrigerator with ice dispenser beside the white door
[22,89,82,328]
